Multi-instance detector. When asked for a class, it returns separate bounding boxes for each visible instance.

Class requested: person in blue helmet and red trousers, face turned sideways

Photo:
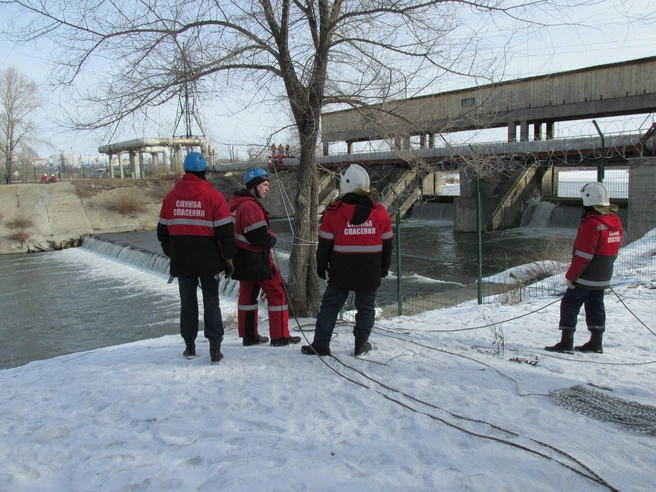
[229,167,301,347]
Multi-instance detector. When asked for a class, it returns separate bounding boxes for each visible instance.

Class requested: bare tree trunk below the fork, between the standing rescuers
[287,136,319,317]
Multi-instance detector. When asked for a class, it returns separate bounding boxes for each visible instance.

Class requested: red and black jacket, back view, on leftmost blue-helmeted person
[157,173,237,277]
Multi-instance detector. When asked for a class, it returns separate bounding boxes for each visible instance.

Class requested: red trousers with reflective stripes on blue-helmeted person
[237,264,289,340]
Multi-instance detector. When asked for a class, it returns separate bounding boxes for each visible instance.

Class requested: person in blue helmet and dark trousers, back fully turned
[157,152,237,364]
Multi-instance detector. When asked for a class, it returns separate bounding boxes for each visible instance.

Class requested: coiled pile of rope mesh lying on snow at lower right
[549,386,656,436]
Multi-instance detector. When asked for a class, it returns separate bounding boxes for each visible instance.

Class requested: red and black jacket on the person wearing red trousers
[229,189,277,282]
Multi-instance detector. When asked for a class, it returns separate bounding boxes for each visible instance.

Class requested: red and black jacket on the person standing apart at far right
[565,209,624,290]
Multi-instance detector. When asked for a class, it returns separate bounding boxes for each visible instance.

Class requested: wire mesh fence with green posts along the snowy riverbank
[379,158,656,316]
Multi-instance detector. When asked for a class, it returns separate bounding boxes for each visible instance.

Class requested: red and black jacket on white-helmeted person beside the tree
[317,193,394,292]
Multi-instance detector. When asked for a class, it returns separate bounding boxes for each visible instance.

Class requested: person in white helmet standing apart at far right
[544,183,624,354]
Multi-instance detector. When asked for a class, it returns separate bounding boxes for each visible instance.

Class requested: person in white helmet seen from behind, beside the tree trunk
[301,164,394,355]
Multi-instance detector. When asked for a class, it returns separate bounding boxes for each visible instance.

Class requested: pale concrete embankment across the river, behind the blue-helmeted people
[0,171,295,254]
